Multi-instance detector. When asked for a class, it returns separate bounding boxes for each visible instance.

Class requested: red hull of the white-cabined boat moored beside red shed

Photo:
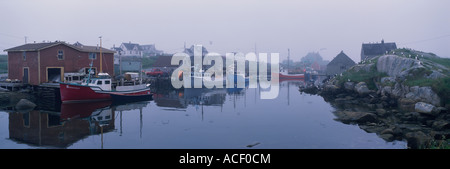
[59,83,111,102]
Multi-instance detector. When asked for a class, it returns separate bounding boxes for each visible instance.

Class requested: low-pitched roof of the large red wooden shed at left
[4,41,115,53]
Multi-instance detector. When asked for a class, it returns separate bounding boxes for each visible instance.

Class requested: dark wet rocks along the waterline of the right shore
[300,82,450,148]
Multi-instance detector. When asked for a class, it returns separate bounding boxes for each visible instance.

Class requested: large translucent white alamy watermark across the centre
[171,45,280,99]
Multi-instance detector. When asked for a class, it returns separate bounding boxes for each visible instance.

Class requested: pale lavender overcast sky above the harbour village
[0,0,450,62]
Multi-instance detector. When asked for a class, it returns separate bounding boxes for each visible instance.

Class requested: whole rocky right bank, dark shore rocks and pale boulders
[299,52,450,149]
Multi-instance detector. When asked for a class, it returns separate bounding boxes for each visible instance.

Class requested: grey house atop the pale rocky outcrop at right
[361,40,397,61]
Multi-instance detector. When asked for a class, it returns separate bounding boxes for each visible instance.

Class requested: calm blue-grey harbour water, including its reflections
[0,81,406,149]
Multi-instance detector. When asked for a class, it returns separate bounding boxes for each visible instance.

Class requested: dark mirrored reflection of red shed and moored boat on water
[9,97,149,148]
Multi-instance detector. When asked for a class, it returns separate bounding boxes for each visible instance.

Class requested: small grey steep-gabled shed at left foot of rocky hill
[326,51,355,75]
